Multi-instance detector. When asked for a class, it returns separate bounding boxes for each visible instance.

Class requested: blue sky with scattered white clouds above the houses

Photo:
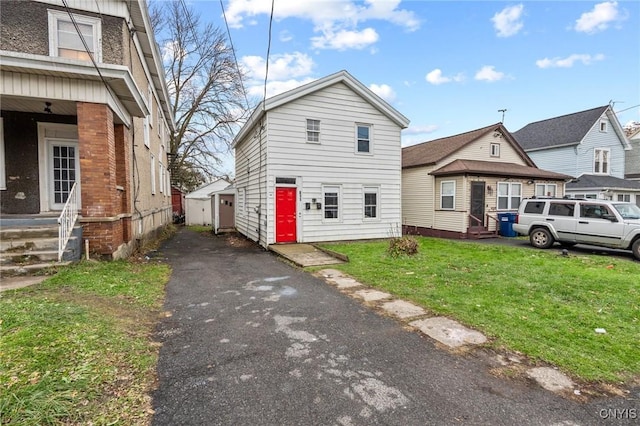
[180,0,640,173]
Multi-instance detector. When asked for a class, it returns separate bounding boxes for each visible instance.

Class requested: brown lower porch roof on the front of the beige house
[430,160,571,180]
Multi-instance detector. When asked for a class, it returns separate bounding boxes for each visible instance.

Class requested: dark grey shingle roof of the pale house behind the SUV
[512,105,609,152]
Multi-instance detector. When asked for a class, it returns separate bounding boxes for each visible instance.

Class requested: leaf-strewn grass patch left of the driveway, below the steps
[0,261,170,425]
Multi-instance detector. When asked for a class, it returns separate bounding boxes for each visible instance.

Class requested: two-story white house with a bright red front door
[233,71,409,247]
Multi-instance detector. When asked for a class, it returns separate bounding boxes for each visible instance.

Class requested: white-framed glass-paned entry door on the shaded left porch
[45,138,80,210]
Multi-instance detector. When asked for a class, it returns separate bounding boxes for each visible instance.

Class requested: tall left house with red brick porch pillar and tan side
[0,0,175,258]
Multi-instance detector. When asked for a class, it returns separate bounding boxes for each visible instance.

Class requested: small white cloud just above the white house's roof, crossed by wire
[241,52,315,81]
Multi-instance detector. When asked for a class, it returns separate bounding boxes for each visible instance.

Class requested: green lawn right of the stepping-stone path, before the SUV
[318,238,640,383]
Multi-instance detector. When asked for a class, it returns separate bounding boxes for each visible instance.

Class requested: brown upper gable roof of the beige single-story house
[402,123,535,169]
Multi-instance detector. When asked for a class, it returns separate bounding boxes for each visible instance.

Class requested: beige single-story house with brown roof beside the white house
[402,123,571,238]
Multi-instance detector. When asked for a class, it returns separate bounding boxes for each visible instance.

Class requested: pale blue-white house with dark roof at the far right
[512,105,640,205]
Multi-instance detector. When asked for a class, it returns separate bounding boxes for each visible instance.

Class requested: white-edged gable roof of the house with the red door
[232,70,409,148]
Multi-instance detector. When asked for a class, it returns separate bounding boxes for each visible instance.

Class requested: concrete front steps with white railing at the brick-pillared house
[0,217,82,277]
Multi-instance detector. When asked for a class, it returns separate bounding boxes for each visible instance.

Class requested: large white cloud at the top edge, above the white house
[226,0,420,50]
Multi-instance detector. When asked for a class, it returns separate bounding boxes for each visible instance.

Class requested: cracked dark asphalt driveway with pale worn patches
[153,229,640,426]
